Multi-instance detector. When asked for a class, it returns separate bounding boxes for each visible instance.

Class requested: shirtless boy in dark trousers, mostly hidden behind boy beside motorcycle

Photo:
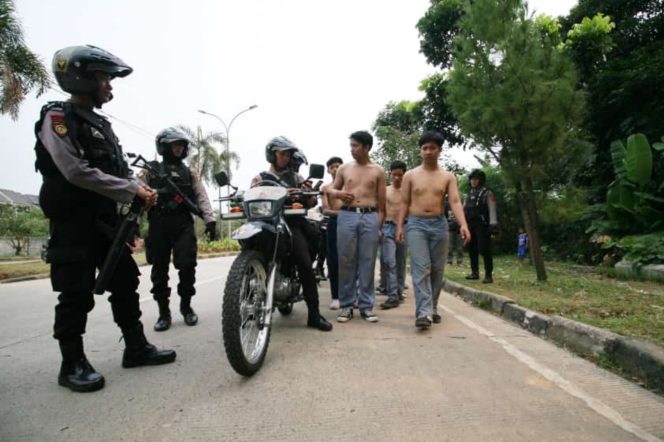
[321,157,343,310]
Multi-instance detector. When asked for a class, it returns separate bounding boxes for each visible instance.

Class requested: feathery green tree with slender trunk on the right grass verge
[447,0,588,281]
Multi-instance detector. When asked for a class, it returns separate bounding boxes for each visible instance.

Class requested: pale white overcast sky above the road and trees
[0,0,576,197]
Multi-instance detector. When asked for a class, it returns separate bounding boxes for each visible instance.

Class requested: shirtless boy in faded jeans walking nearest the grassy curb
[396,132,470,329]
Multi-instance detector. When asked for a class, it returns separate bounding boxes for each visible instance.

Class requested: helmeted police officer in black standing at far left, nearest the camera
[35,46,175,391]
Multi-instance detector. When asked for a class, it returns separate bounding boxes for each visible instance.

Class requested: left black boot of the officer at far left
[58,336,104,392]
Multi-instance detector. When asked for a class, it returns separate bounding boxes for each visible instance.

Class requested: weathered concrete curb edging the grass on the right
[443,280,664,393]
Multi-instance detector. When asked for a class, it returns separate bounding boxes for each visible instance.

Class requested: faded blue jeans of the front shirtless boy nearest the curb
[405,216,449,318]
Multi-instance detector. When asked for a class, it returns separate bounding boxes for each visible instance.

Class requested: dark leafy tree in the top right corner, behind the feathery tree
[562,0,664,202]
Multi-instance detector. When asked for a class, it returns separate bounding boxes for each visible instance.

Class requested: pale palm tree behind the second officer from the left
[178,125,240,184]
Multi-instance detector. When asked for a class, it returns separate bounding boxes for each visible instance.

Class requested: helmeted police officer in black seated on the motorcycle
[252,137,332,331]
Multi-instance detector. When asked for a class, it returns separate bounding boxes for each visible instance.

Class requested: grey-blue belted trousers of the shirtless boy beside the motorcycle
[337,210,378,311]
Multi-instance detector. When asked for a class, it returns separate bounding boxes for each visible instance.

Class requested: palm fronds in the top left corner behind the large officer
[0,0,51,120]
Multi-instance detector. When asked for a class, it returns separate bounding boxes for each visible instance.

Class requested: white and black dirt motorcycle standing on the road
[215,164,325,376]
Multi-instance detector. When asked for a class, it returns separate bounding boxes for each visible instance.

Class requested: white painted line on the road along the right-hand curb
[438,305,662,442]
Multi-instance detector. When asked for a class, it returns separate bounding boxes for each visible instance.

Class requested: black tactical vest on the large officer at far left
[35,102,130,218]
